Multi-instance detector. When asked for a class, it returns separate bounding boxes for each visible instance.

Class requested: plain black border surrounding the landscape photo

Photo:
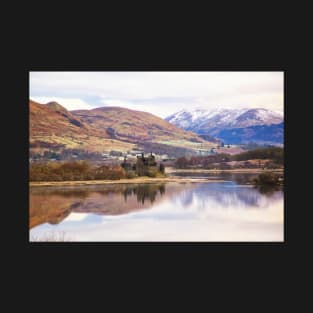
[2,3,309,312]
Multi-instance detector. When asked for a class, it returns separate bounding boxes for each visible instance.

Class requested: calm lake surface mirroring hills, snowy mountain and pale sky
[30,174,284,241]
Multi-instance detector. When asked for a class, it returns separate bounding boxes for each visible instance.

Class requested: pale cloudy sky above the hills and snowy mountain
[29,72,284,118]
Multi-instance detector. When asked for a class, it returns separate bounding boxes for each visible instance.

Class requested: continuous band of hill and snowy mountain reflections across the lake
[29,179,283,228]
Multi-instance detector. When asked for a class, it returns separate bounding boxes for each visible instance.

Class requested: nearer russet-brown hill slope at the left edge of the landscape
[29,100,134,152]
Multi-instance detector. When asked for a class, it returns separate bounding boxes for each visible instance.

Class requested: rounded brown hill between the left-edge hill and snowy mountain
[71,107,214,149]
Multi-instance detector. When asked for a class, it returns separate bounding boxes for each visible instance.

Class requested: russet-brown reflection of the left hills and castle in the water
[30,184,168,228]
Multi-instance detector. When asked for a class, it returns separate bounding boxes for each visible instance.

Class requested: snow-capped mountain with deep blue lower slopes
[166,108,284,144]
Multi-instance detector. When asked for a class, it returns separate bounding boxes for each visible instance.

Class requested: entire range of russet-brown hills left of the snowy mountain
[29,100,216,154]
